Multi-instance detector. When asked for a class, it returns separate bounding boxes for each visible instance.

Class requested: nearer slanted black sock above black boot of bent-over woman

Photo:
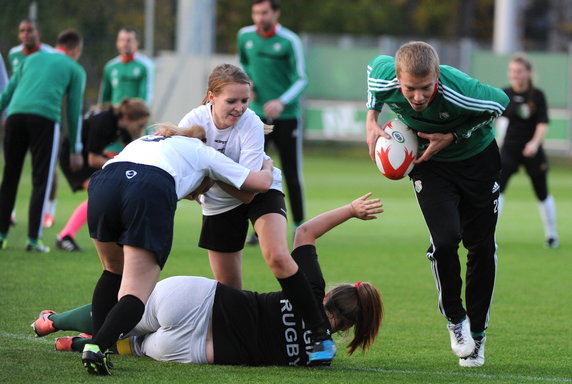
[91,295,145,352]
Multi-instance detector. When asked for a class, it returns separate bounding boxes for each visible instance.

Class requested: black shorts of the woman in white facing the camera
[199,189,287,252]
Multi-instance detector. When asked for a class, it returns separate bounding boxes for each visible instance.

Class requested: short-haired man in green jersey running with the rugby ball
[366,42,508,367]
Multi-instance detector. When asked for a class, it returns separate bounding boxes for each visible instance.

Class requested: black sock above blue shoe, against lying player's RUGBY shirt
[277,269,330,341]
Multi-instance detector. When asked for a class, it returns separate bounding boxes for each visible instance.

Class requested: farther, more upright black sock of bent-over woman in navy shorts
[91,271,121,335]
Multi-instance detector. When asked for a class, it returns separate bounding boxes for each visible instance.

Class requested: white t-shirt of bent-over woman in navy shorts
[104,135,250,200]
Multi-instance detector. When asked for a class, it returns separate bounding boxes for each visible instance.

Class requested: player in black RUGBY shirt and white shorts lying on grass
[32,193,383,365]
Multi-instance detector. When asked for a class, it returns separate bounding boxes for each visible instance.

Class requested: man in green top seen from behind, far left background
[0,30,85,252]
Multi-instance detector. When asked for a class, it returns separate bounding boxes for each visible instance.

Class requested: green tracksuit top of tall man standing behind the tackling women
[238,24,308,119]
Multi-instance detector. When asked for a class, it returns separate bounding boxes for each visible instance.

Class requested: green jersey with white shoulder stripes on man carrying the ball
[367,55,509,161]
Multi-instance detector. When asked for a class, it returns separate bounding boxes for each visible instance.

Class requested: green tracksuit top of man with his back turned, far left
[0,52,86,153]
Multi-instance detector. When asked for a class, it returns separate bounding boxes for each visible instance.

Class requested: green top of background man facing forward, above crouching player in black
[99,52,154,105]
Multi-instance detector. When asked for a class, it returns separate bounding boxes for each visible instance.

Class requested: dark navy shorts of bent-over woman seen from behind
[87,162,177,269]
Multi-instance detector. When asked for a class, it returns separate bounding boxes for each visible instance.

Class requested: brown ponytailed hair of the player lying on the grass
[324,282,383,355]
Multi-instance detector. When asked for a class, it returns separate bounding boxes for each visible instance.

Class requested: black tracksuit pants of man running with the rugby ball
[410,141,500,333]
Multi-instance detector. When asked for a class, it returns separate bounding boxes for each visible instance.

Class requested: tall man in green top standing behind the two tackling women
[238,0,308,244]
